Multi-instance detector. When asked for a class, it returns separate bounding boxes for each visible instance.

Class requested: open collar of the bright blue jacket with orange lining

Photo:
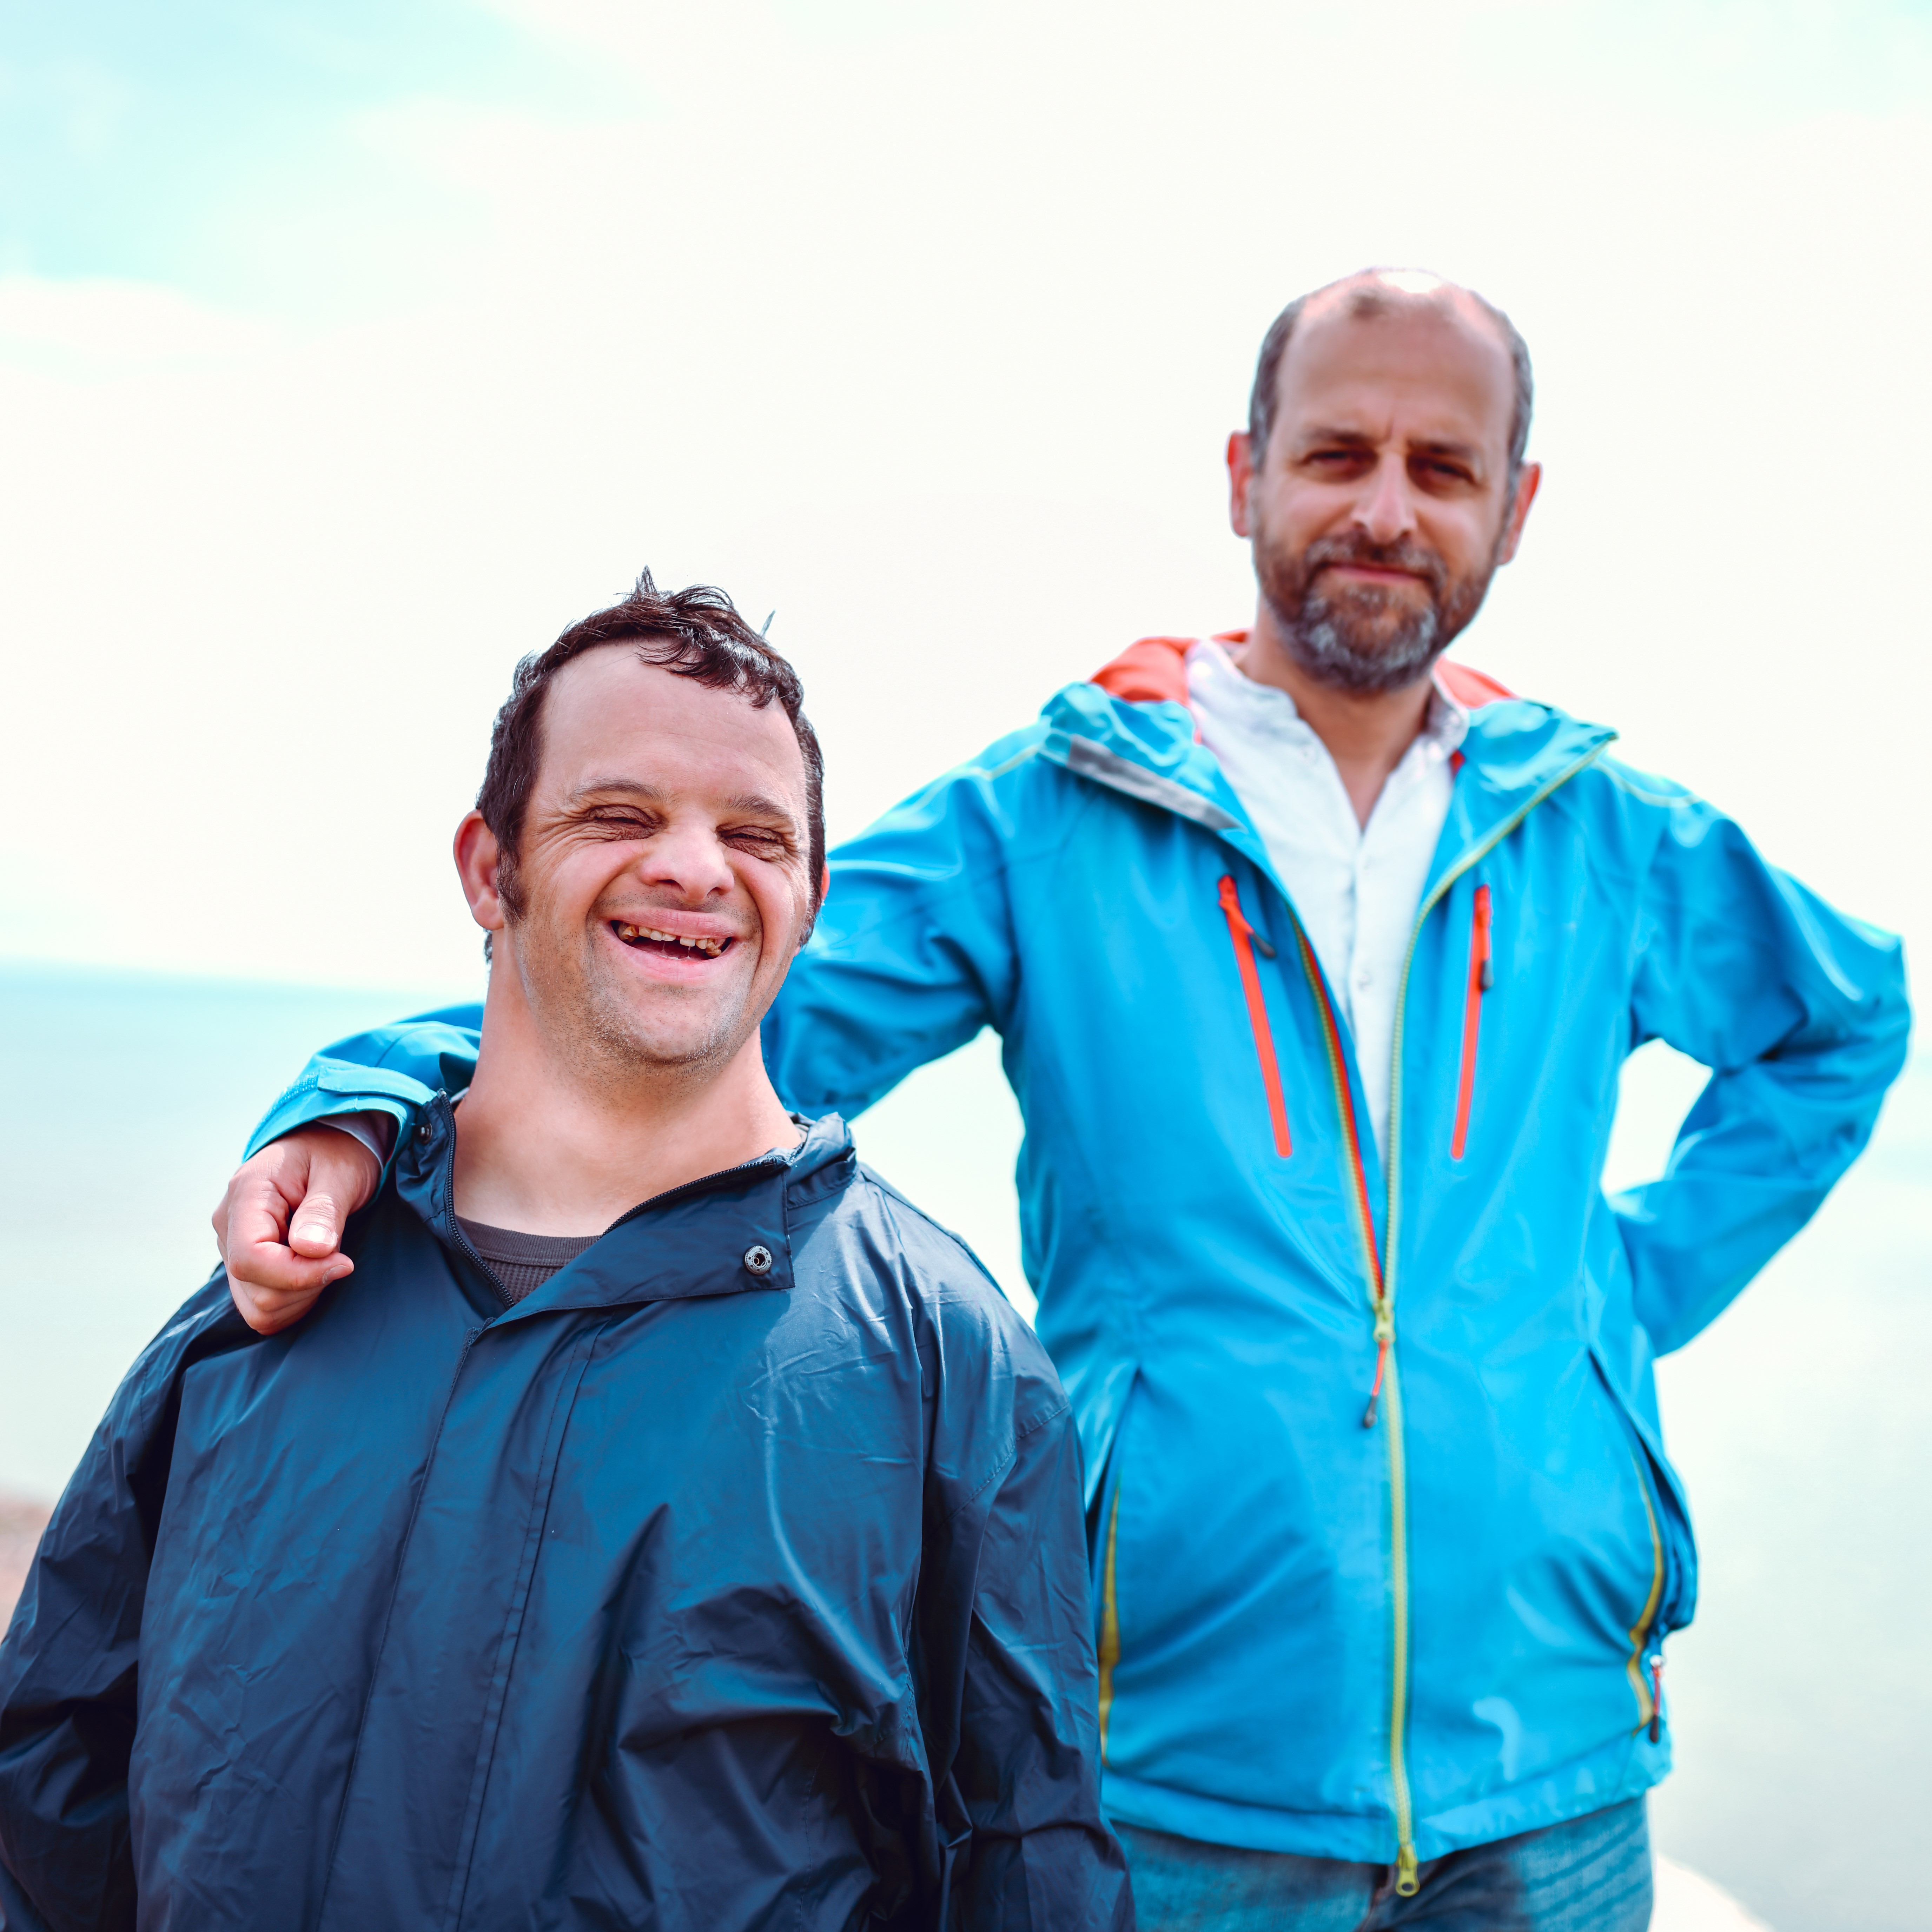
[1041,634,1617,898]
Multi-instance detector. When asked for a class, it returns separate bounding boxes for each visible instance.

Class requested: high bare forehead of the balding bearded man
[1275,298,1517,450]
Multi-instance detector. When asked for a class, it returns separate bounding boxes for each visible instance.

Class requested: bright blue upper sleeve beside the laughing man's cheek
[763,728,1051,1119]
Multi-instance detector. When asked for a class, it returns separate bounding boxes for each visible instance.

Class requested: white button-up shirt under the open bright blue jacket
[1188,640,1468,1161]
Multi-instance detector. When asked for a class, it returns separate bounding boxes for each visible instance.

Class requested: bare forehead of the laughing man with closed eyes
[537,643,806,817]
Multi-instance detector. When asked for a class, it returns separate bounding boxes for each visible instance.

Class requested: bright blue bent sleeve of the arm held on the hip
[1611,773,1911,1354]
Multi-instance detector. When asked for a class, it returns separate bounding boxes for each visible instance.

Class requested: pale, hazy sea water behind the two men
[0,964,1932,1932]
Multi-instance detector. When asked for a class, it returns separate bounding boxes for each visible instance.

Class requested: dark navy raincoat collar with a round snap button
[394,1093,858,1327]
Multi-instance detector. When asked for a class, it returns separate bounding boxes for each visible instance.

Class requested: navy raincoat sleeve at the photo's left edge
[0,1275,247,1932]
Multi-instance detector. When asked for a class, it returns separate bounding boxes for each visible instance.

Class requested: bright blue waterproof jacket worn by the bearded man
[207,645,1909,1864]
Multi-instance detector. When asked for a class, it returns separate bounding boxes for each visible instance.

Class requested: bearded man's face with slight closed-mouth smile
[1229,299,1536,694]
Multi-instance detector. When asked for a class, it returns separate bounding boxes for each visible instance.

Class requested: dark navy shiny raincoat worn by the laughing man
[0,1113,1132,1932]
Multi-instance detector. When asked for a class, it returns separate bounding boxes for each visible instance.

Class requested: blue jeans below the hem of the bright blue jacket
[1115,1799,1650,1932]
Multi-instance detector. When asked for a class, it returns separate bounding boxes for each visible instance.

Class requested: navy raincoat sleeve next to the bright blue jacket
[921,1337,1134,1932]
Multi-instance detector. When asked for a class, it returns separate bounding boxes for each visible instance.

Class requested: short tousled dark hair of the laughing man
[477,570,825,956]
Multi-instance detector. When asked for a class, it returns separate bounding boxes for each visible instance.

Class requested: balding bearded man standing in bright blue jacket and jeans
[207,272,1909,1932]
